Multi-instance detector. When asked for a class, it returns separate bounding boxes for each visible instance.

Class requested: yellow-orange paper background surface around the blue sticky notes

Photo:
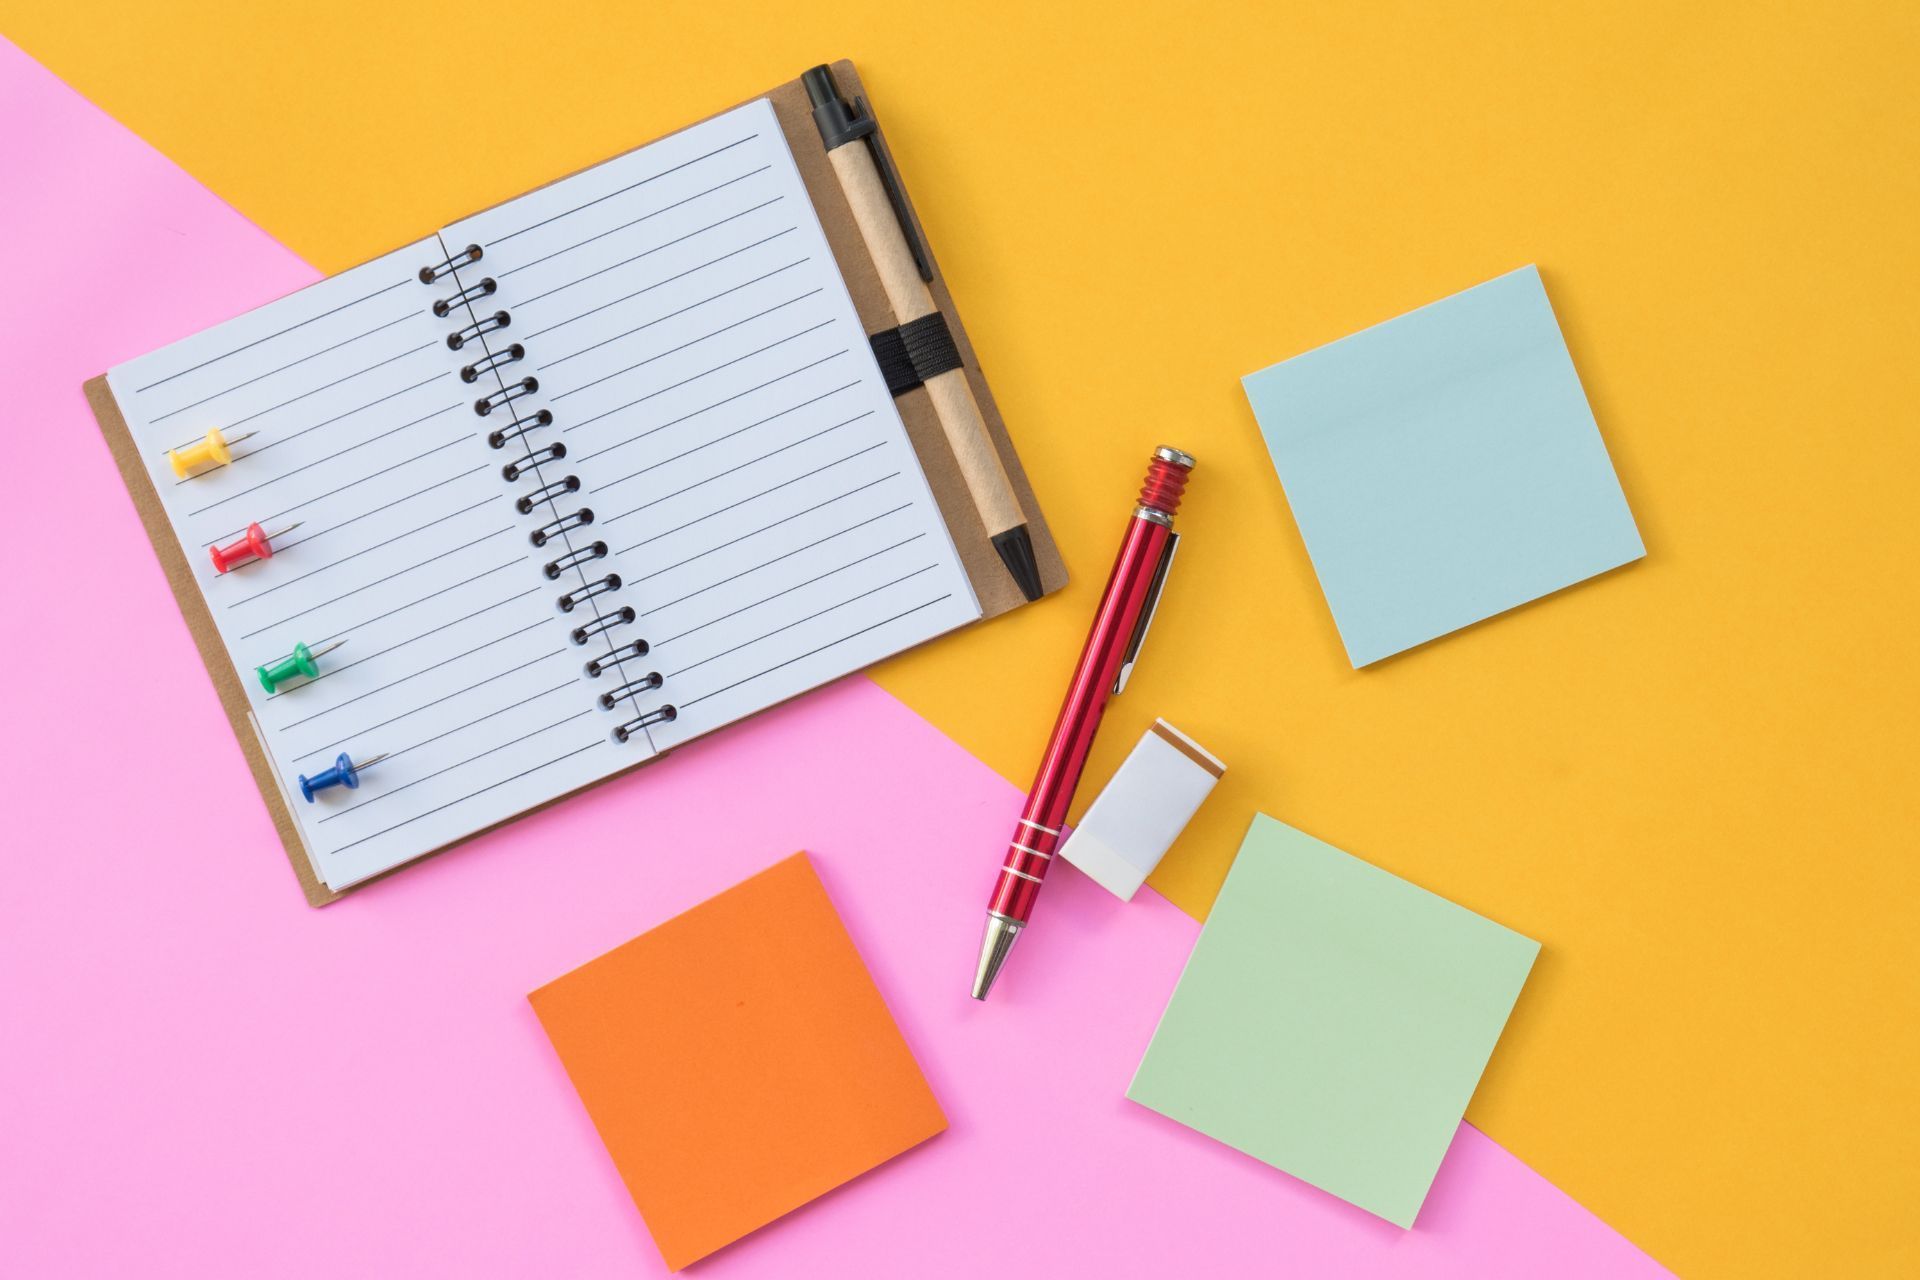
[0,0,1920,1276]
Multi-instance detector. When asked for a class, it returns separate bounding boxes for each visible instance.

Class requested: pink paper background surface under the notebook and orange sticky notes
[0,40,1665,1278]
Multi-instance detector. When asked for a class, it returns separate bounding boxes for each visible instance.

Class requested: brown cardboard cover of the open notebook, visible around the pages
[86,59,1068,906]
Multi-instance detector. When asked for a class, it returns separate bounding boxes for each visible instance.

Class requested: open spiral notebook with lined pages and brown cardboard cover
[88,63,1064,904]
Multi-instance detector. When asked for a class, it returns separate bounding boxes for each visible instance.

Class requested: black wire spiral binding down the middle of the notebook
[419,244,680,743]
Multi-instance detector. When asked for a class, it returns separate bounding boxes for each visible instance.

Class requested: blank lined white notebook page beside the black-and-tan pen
[444,100,979,759]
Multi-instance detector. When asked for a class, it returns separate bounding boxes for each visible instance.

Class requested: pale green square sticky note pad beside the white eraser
[1127,814,1540,1226]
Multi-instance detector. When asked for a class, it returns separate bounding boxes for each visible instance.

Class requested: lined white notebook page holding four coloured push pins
[108,240,645,887]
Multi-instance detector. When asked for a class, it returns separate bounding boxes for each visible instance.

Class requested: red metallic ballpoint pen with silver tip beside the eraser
[973,445,1194,1000]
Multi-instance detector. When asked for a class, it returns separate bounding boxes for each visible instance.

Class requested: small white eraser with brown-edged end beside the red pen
[1060,720,1227,900]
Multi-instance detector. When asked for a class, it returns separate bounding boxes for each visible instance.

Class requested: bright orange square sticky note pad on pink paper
[528,854,947,1270]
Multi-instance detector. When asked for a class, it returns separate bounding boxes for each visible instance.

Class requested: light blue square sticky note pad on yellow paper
[1242,267,1645,666]
